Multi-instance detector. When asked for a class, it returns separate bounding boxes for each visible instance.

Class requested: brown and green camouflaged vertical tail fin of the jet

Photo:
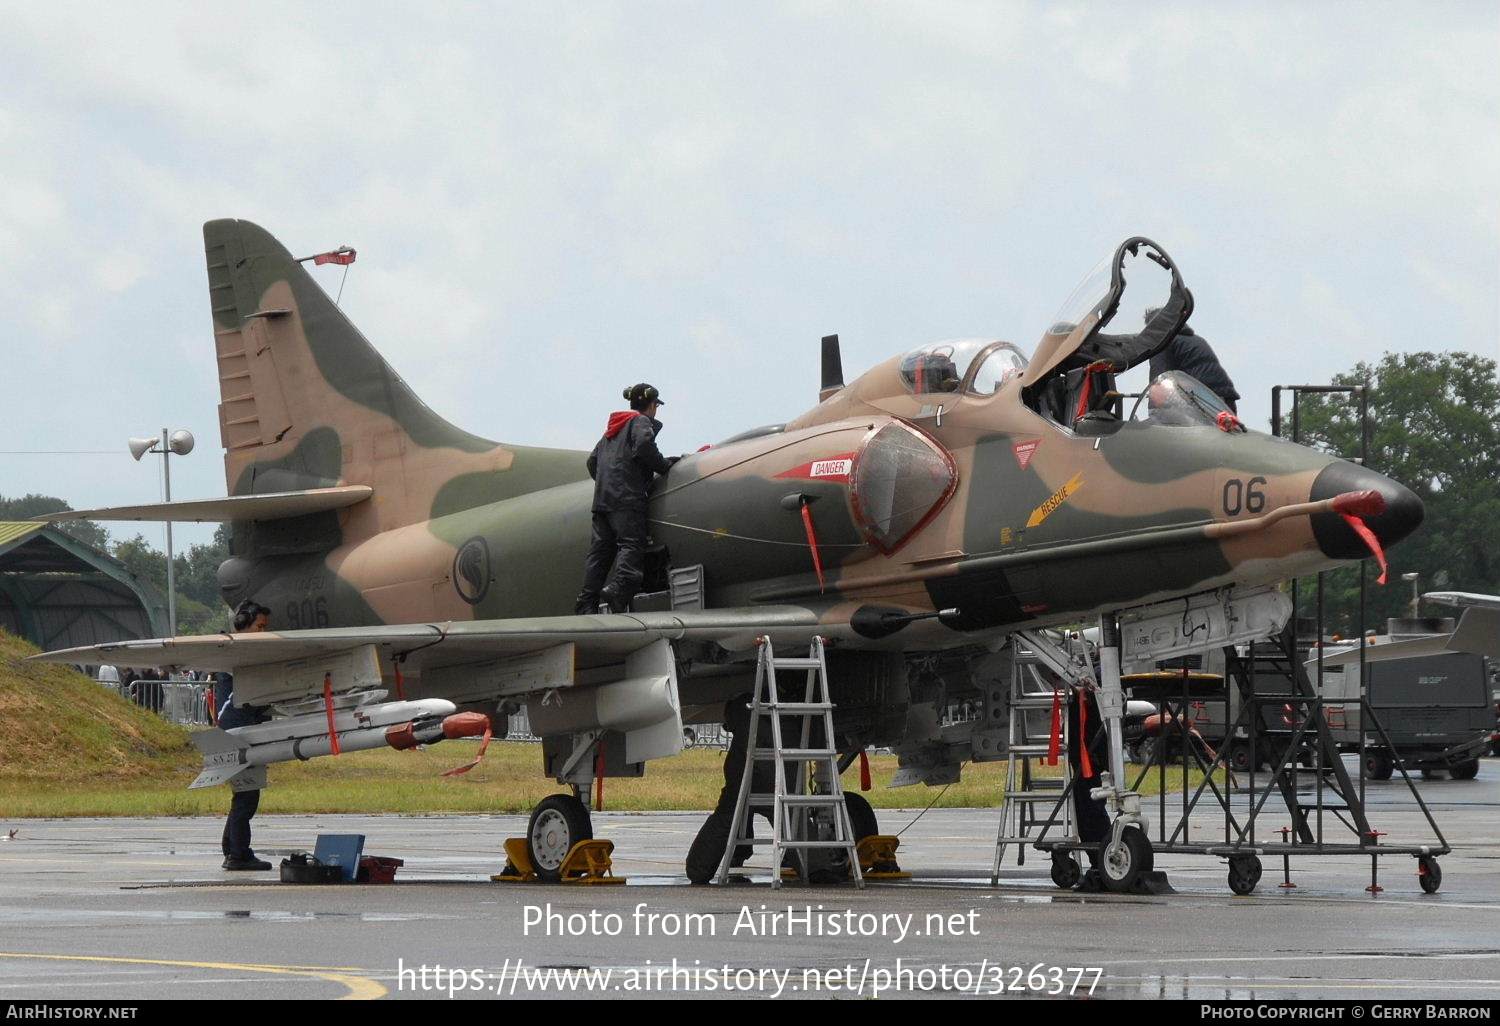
[203,219,584,555]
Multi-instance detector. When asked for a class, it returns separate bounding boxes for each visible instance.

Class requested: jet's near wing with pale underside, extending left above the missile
[32,606,849,782]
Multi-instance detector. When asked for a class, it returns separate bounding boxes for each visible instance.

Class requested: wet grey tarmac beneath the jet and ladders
[0,759,1500,1002]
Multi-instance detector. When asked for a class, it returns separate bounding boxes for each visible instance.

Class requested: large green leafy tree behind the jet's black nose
[1298,353,1500,633]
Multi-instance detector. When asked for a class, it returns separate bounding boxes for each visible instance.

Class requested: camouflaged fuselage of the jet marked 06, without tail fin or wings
[217,340,1421,647]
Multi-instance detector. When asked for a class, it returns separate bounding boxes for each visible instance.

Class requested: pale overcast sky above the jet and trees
[0,0,1500,545]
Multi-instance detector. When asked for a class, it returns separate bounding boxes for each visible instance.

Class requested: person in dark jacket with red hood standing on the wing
[573,381,677,615]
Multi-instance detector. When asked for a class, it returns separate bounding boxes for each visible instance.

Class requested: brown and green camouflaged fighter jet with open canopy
[29,221,1422,875]
